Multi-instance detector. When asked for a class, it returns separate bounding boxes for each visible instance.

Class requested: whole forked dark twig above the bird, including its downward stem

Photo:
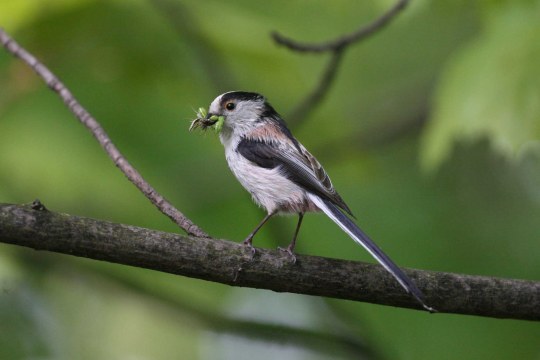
[271,0,409,125]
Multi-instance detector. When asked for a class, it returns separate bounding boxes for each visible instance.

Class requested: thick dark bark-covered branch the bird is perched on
[0,204,540,321]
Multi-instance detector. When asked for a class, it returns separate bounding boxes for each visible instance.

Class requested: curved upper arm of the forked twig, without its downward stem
[272,0,409,53]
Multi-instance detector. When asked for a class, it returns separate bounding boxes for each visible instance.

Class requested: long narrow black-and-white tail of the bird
[308,194,435,312]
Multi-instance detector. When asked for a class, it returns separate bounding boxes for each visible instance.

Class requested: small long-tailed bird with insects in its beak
[190,91,435,312]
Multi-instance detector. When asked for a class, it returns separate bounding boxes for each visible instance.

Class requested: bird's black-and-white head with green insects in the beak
[191,91,274,133]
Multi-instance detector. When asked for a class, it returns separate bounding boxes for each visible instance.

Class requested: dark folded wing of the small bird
[236,138,353,216]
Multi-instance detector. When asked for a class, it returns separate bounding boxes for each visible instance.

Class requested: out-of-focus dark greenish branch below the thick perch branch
[17,252,376,360]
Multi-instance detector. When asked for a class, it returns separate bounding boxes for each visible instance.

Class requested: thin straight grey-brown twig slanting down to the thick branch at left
[0,28,209,237]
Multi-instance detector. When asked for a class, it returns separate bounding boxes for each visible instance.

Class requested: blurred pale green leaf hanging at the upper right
[421,4,540,170]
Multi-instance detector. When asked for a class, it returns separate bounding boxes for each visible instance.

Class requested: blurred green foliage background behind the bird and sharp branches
[0,0,540,360]
